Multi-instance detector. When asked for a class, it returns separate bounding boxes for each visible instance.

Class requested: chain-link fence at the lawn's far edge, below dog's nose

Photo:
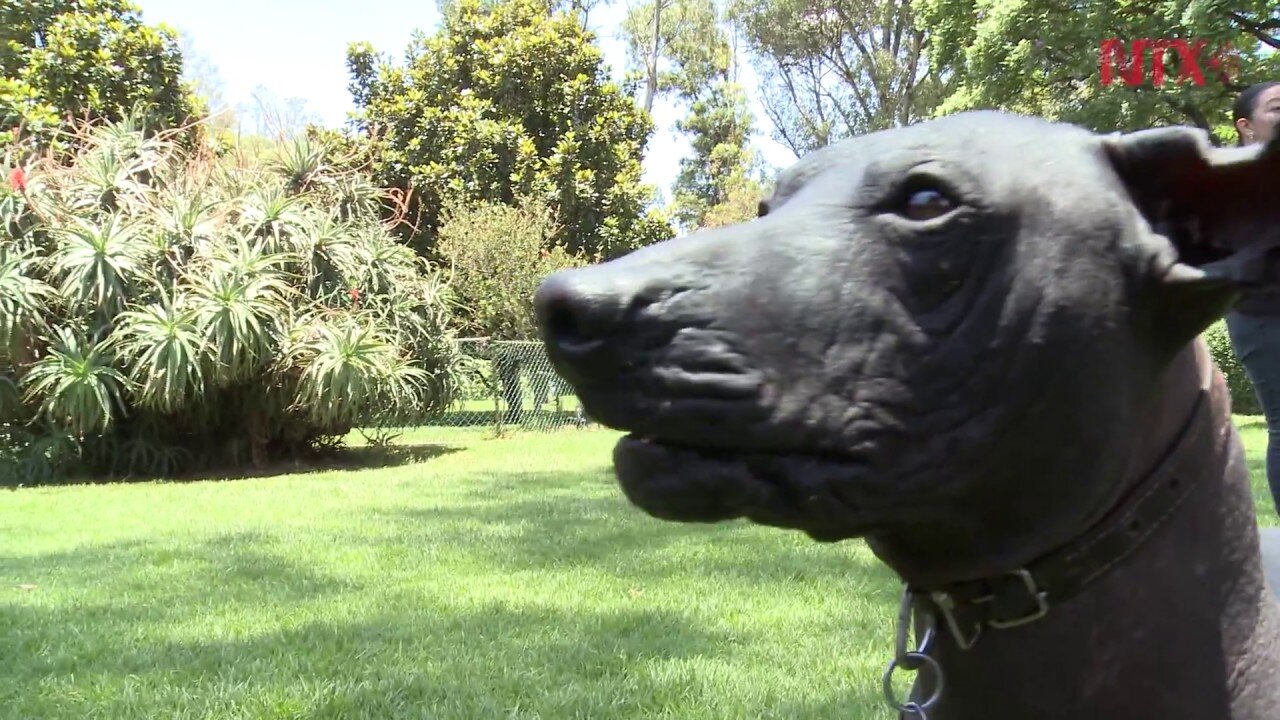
[424,338,590,434]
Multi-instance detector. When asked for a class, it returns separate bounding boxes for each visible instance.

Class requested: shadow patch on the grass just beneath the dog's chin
[378,469,897,594]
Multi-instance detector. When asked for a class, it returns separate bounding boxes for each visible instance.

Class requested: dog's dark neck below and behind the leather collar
[916,342,1280,720]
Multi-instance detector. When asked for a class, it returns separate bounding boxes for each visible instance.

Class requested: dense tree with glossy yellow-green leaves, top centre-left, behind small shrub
[348,0,672,258]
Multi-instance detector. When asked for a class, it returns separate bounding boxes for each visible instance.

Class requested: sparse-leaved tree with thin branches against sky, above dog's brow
[732,0,948,156]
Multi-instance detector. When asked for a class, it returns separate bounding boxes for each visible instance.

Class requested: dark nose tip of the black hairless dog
[534,270,626,361]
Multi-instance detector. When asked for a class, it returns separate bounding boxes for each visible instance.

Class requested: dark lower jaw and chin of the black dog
[613,436,876,542]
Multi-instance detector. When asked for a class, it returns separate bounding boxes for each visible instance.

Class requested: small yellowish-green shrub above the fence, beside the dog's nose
[438,193,590,340]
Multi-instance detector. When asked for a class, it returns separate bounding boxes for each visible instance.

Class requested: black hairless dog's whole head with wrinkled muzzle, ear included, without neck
[535,113,1280,584]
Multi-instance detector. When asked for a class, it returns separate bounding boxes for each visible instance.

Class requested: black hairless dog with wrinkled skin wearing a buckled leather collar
[535,111,1280,720]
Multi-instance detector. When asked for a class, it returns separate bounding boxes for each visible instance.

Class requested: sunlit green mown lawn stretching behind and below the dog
[0,418,1276,720]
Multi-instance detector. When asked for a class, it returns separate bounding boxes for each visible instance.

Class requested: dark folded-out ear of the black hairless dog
[1103,127,1280,347]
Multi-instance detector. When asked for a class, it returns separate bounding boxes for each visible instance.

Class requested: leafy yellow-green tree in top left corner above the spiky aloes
[0,0,202,149]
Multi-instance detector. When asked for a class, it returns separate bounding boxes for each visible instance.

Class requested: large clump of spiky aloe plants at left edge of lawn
[0,116,454,482]
